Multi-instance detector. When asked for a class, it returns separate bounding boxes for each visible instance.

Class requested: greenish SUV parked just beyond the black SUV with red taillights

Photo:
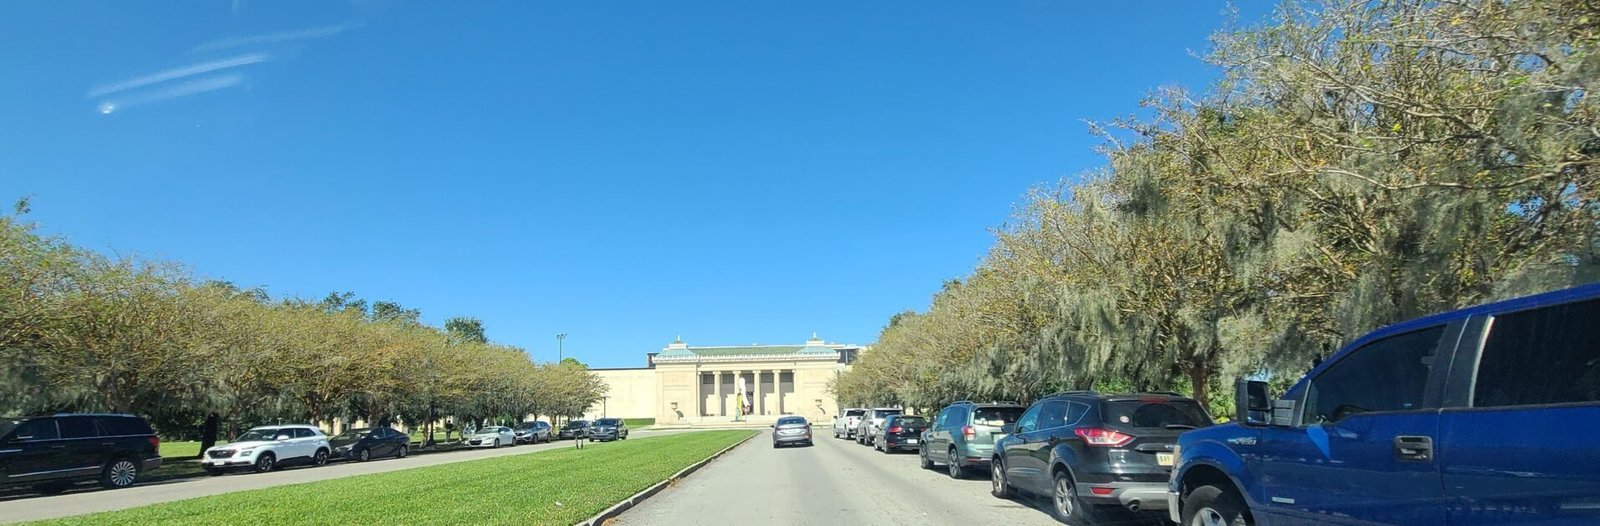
[918,401,1027,478]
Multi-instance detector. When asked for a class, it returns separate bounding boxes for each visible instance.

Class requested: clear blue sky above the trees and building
[0,0,1266,366]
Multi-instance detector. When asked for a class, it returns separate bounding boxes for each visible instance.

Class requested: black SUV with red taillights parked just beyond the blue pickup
[990,392,1211,524]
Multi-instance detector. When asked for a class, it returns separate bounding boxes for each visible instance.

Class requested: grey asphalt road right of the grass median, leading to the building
[616,427,1113,526]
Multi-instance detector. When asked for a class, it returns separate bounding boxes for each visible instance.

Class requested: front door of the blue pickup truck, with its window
[1254,325,1459,524]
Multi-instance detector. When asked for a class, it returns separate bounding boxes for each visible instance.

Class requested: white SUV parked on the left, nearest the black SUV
[200,424,333,475]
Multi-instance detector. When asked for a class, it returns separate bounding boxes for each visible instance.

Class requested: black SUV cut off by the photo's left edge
[0,414,162,492]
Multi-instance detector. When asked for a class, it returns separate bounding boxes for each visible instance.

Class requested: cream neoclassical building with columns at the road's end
[587,334,861,424]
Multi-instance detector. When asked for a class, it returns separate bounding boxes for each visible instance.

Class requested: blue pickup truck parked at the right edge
[1168,285,1600,526]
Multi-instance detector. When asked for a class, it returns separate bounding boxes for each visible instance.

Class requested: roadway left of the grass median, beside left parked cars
[0,430,678,523]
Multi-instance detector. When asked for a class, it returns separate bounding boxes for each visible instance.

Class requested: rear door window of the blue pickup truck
[1472,294,1600,408]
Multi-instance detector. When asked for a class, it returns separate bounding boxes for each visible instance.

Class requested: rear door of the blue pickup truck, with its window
[1438,299,1600,524]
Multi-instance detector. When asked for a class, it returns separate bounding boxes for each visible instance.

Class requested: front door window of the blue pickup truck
[1301,326,1445,424]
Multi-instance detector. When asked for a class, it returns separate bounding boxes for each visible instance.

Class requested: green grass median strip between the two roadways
[32,430,754,524]
